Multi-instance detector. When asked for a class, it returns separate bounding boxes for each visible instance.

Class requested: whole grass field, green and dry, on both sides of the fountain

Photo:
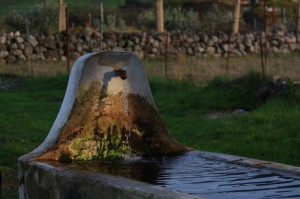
[0,55,300,198]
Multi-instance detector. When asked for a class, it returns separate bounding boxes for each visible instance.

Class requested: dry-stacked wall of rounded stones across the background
[0,31,300,64]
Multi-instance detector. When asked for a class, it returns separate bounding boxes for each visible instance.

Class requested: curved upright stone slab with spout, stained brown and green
[20,52,189,162]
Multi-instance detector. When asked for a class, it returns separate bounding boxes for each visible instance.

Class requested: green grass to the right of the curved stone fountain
[151,74,300,166]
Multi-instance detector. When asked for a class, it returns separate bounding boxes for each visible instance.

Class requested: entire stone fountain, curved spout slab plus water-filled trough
[19,52,300,199]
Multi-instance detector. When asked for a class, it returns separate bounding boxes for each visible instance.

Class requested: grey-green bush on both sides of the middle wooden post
[138,7,199,31]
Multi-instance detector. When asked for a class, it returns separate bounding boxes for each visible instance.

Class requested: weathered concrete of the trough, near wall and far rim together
[19,151,300,199]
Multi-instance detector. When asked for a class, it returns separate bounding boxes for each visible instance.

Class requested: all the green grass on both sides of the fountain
[0,73,300,198]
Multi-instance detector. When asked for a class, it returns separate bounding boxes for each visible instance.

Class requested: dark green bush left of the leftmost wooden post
[4,0,58,33]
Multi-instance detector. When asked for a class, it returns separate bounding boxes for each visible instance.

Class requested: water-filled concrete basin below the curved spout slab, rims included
[20,150,300,199]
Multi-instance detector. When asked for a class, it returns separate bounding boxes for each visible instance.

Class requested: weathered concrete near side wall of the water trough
[19,162,200,199]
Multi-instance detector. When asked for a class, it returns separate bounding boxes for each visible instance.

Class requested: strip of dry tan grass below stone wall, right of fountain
[144,53,300,84]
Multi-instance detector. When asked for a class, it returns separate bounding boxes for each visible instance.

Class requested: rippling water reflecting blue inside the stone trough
[50,151,300,199]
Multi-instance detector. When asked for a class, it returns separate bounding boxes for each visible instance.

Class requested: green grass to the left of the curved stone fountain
[0,76,67,167]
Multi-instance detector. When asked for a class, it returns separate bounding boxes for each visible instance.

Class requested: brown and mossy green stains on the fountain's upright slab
[36,78,188,162]
